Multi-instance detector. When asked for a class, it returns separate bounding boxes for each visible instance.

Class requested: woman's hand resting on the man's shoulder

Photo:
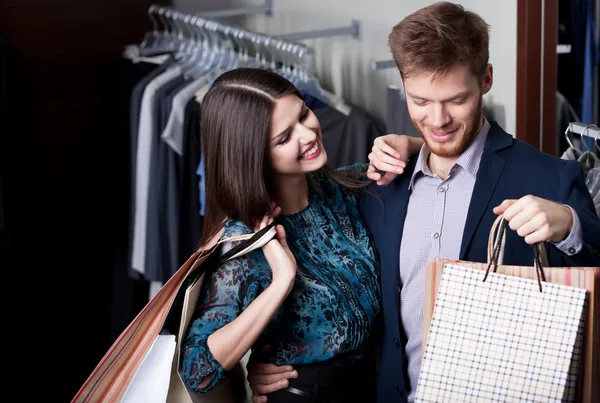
[367,134,423,186]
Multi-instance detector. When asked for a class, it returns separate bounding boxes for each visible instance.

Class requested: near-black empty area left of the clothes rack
[0,0,165,402]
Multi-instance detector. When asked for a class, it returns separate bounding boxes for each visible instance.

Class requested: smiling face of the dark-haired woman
[268,94,327,175]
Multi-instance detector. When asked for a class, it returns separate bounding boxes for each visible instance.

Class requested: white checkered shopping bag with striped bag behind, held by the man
[415,217,600,403]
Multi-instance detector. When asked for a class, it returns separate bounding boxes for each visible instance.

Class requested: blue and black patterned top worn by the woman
[182,166,381,392]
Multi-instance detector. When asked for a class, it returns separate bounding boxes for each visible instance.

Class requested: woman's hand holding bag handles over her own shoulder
[255,207,296,293]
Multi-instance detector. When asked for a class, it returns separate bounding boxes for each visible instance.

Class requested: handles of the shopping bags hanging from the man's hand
[483,215,548,292]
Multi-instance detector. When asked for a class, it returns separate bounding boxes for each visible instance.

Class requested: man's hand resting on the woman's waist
[246,360,298,403]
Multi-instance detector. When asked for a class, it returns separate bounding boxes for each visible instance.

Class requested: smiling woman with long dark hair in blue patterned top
[182,69,422,402]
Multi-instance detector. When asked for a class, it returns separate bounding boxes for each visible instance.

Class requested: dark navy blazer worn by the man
[360,122,600,403]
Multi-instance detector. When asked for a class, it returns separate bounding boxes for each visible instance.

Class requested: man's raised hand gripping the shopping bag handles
[494,195,573,245]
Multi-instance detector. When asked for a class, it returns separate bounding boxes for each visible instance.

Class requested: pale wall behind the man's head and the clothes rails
[175,0,517,133]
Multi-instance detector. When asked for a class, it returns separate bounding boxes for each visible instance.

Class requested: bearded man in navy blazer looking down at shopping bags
[249,2,600,402]
